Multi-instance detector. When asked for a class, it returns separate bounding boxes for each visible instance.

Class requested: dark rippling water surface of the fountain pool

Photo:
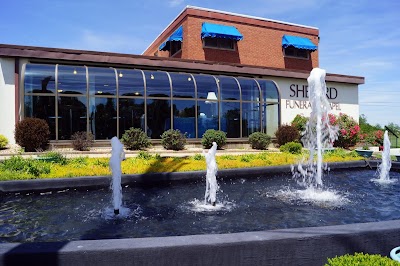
[0,170,400,242]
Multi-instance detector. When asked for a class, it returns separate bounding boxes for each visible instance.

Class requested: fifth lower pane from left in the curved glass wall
[146,99,171,139]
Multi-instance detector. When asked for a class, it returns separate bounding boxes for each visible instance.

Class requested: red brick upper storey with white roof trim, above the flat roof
[143,6,319,71]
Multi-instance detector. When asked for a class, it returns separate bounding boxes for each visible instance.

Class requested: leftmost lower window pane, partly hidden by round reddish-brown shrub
[24,95,56,140]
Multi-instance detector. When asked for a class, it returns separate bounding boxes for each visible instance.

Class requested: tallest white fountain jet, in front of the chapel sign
[292,68,338,191]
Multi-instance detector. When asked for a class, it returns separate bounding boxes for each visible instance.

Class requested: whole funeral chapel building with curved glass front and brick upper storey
[0,6,364,144]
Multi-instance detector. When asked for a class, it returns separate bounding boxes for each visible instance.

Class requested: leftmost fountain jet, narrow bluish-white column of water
[109,137,125,215]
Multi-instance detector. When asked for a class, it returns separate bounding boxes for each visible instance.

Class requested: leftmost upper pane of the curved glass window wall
[24,64,55,93]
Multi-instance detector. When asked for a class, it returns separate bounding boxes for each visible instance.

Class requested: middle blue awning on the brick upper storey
[201,22,243,41]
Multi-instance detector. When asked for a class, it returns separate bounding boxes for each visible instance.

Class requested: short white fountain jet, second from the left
[203,142,219,206]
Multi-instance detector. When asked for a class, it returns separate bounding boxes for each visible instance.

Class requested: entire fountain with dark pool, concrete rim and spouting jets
[0,69,400,265]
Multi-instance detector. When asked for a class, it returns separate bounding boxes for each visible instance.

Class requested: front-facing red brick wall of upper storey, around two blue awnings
[182,17,318,70]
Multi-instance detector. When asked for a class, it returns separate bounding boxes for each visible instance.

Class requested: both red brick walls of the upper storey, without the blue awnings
[144,9,319,70]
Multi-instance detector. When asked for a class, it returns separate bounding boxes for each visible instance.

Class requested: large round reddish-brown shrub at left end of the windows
[14,117,50,152]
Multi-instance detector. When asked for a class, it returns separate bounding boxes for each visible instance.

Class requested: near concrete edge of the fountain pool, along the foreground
[0,220,400,266]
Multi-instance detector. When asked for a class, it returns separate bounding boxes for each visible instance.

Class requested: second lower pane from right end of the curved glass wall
[242,102,261,137]
